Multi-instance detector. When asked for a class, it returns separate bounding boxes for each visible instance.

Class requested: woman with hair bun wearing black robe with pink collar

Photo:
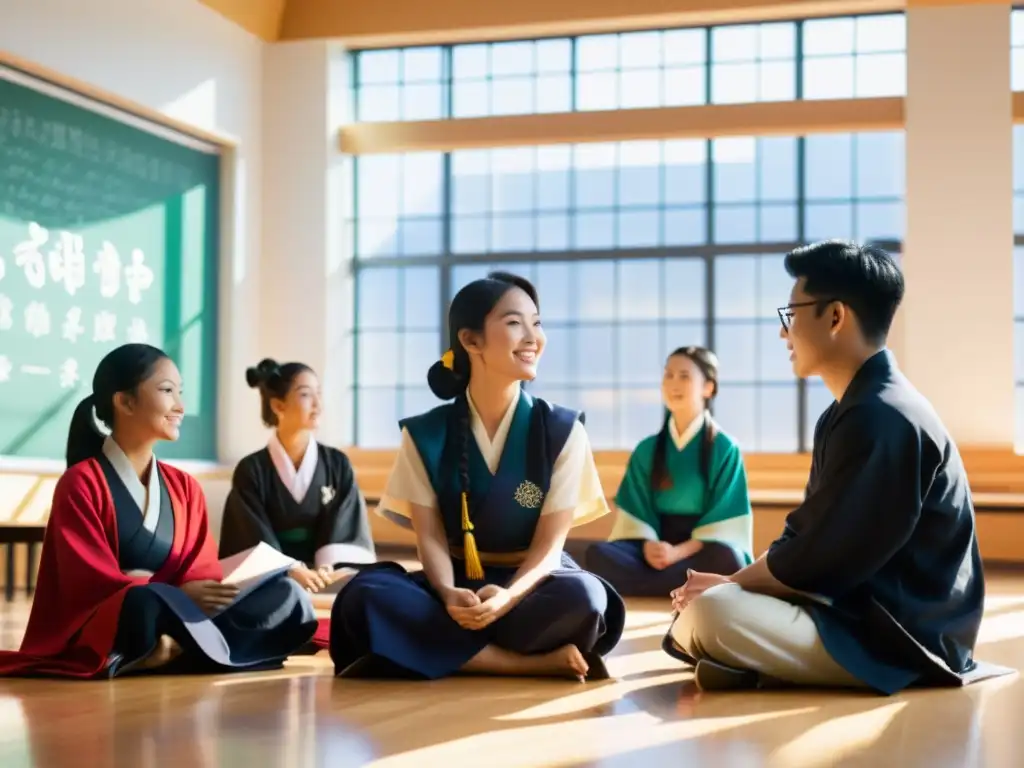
[220,359,376,593]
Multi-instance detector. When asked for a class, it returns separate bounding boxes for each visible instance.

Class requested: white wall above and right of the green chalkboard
[0,0,264,462]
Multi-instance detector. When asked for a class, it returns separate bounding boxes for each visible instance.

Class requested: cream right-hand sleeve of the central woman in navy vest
[541,421,610,527]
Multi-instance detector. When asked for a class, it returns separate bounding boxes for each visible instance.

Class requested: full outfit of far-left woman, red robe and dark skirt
[0,438,316,678]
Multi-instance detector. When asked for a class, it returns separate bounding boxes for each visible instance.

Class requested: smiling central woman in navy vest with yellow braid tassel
[331,272,625,680]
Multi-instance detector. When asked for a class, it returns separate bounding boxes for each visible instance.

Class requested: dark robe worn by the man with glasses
[767,350,1008,693]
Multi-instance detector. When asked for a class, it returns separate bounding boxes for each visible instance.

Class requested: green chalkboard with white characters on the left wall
[0,65,220,459]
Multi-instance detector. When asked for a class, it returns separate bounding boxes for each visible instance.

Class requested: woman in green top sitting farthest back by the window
[587,346,754,597]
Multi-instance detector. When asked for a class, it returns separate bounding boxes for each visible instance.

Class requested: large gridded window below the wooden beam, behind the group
[352,132,904,452]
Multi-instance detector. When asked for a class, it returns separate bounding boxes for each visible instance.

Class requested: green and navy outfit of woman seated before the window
[586,414,754,597]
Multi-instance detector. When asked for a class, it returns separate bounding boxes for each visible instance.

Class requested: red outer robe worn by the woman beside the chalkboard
[0,459,326,678]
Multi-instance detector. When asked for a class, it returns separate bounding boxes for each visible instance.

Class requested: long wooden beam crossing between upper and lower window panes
[339,97,904,155]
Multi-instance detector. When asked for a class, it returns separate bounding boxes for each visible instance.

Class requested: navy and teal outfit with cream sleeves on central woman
[331,391,625,679]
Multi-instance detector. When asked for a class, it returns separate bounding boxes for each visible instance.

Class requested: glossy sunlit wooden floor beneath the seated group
[0,574,1024,768]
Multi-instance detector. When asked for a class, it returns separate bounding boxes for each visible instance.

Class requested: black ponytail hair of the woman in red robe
[65,344,167,467]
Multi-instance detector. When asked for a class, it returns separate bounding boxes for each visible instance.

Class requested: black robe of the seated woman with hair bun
[218,444,376,567]
